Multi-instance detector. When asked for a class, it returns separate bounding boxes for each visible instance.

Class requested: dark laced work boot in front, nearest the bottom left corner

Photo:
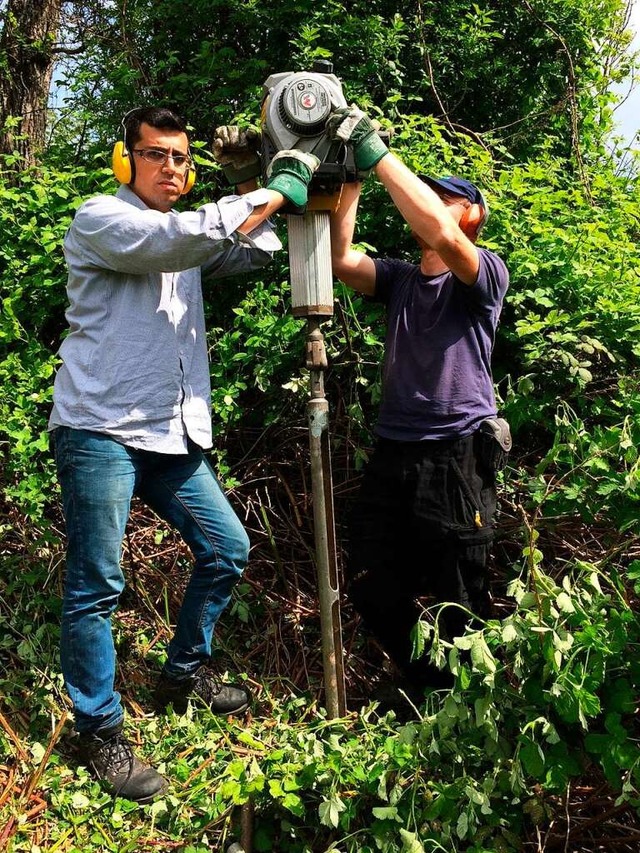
[77,725,166,803]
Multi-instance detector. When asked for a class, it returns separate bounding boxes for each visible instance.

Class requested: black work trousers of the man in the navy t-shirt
[346,432,496,684]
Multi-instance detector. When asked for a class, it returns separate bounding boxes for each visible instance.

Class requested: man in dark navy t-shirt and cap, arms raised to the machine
[328,107,509,700]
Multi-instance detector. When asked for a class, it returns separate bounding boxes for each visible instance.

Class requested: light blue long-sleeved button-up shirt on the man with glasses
[49,186,281,453]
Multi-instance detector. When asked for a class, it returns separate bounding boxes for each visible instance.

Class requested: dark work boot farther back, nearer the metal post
[153,666,251,716]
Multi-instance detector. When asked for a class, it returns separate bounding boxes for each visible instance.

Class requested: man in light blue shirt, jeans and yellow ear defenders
[50,107,317,802]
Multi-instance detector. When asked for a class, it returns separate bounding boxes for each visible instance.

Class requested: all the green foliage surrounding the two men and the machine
[0,0,640,853]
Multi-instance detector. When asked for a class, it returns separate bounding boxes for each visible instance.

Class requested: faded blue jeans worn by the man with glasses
[53,427,249,732]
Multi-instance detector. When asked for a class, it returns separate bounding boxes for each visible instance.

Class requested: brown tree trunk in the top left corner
[0,0,62,165]
